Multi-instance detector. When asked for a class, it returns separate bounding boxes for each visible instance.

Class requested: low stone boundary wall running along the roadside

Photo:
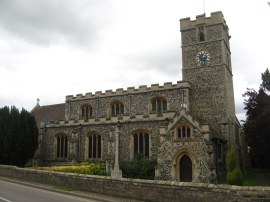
[0,165,270,202]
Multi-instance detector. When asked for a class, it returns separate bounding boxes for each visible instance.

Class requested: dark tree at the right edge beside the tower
[243,69,270,168]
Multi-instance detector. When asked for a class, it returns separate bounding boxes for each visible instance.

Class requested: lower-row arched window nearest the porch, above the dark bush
[133,131,150,157]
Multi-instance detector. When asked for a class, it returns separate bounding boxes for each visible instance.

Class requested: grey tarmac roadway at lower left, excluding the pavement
[0,180,99,202]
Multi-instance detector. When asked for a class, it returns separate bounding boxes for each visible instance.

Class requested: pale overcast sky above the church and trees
[0,0,270,119]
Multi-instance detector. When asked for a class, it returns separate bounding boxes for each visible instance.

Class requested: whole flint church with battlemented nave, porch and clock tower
[32,11,243,183]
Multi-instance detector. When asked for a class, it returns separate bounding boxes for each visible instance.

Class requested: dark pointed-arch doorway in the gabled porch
[179,155,192,182]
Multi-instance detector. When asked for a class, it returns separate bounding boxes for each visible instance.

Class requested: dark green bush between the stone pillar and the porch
[120,156,156,180]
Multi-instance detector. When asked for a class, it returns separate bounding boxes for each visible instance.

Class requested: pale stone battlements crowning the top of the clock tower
[180,11,227,31]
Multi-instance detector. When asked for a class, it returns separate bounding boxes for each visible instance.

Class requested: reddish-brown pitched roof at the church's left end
[31,103,65,128]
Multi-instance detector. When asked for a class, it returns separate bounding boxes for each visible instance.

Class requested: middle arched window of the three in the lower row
[87,133,101,159]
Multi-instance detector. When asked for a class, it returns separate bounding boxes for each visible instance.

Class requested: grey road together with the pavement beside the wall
[0,177,141,202]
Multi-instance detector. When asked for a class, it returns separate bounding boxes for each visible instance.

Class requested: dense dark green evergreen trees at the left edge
[0,106,38,166]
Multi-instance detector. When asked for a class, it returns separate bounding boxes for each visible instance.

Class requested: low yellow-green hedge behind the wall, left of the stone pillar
[35,163,106,176]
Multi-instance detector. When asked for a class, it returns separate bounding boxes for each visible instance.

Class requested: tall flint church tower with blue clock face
[180,12,239,152]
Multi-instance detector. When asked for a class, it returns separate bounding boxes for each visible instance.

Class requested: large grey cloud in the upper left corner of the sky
[0,0,111,44]
